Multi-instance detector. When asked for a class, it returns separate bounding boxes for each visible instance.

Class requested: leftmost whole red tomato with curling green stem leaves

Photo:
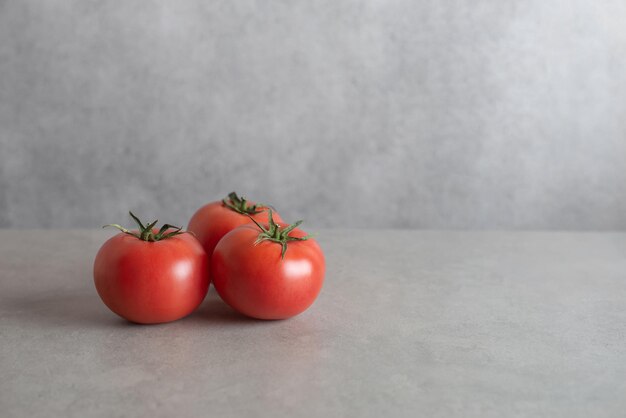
[93,213,209,324]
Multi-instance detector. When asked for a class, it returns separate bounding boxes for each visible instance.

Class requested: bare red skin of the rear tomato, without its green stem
[187,201,281,258]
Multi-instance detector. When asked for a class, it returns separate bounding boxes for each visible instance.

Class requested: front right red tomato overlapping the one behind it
[211,210,325,319]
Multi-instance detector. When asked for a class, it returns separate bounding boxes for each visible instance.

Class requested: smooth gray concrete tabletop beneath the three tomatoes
[0,230,626,418]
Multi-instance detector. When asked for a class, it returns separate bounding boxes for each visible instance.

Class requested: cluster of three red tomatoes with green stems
[94,192,325,324]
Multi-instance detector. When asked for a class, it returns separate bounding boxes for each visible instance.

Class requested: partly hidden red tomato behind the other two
[187,192,281,257]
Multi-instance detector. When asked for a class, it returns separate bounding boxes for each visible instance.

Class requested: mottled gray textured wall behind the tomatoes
[0,0,626,229]
